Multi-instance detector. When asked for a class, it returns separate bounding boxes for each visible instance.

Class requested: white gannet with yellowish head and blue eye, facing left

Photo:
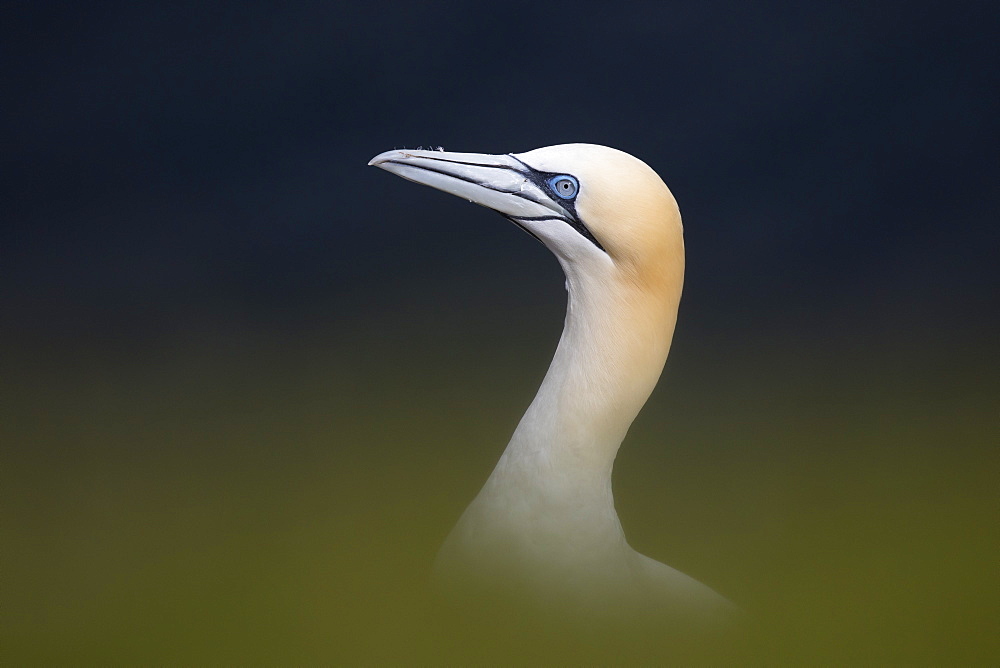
[368,144,735,622]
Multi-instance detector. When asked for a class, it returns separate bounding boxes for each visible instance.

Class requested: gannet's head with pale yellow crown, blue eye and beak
[368,144,683,284]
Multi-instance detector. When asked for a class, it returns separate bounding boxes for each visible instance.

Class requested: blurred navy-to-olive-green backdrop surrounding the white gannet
[0,2,1000,661]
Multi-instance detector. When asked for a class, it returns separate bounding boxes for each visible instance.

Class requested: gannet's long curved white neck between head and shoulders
[484,262,683,523]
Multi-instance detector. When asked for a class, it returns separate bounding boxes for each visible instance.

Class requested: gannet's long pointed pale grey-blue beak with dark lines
[368,150,572,222]
